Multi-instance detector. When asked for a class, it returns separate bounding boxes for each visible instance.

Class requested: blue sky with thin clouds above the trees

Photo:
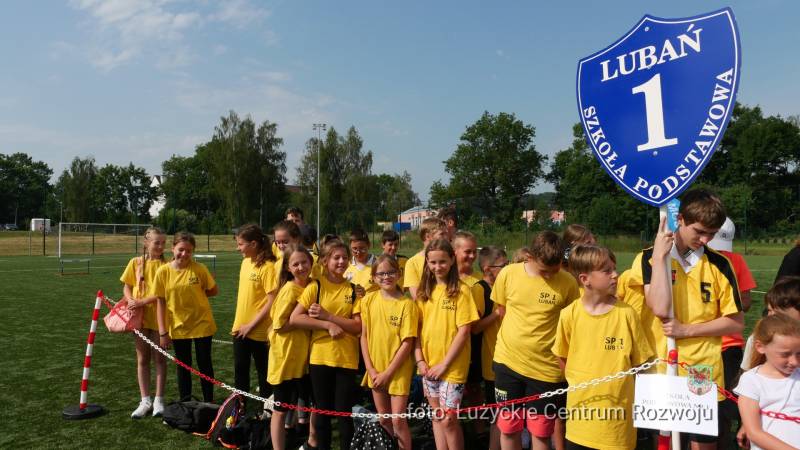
[0,0,800,199]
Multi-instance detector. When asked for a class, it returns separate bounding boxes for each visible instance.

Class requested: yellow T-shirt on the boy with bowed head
[492,263,578,383]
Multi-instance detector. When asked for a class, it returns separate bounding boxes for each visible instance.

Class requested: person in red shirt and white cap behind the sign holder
[708,217,756,444]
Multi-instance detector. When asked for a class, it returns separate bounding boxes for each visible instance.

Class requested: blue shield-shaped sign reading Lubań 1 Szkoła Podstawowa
[577,8,741,206]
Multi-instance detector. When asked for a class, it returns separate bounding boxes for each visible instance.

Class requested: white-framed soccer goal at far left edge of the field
[58,222,151,258]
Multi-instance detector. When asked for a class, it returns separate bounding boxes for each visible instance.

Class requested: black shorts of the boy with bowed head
[492,362,567,416]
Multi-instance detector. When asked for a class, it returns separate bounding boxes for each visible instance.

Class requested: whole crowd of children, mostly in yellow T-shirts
[121,198,800,450]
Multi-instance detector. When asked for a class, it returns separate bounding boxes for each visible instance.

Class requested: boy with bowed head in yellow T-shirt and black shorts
[492,231,578,450]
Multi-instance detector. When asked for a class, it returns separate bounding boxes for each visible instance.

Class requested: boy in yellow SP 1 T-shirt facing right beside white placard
[553,245,655,450]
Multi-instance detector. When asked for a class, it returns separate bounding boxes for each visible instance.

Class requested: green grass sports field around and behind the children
[0,239,782,448]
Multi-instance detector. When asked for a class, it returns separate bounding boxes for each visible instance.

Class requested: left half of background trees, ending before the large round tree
[0,111,419,233]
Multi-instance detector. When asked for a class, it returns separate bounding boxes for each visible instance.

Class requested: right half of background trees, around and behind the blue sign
[430,104,800,236]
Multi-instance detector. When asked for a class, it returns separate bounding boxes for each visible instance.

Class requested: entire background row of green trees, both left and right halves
[0,104,800,236]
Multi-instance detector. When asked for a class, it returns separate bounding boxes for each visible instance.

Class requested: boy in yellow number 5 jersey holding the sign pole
[629,189,744,450]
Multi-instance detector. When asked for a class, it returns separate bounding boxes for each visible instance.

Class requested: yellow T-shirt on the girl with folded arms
[297,277,359,369]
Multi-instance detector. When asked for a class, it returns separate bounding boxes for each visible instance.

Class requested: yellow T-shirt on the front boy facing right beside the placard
[552,300,655,450]
